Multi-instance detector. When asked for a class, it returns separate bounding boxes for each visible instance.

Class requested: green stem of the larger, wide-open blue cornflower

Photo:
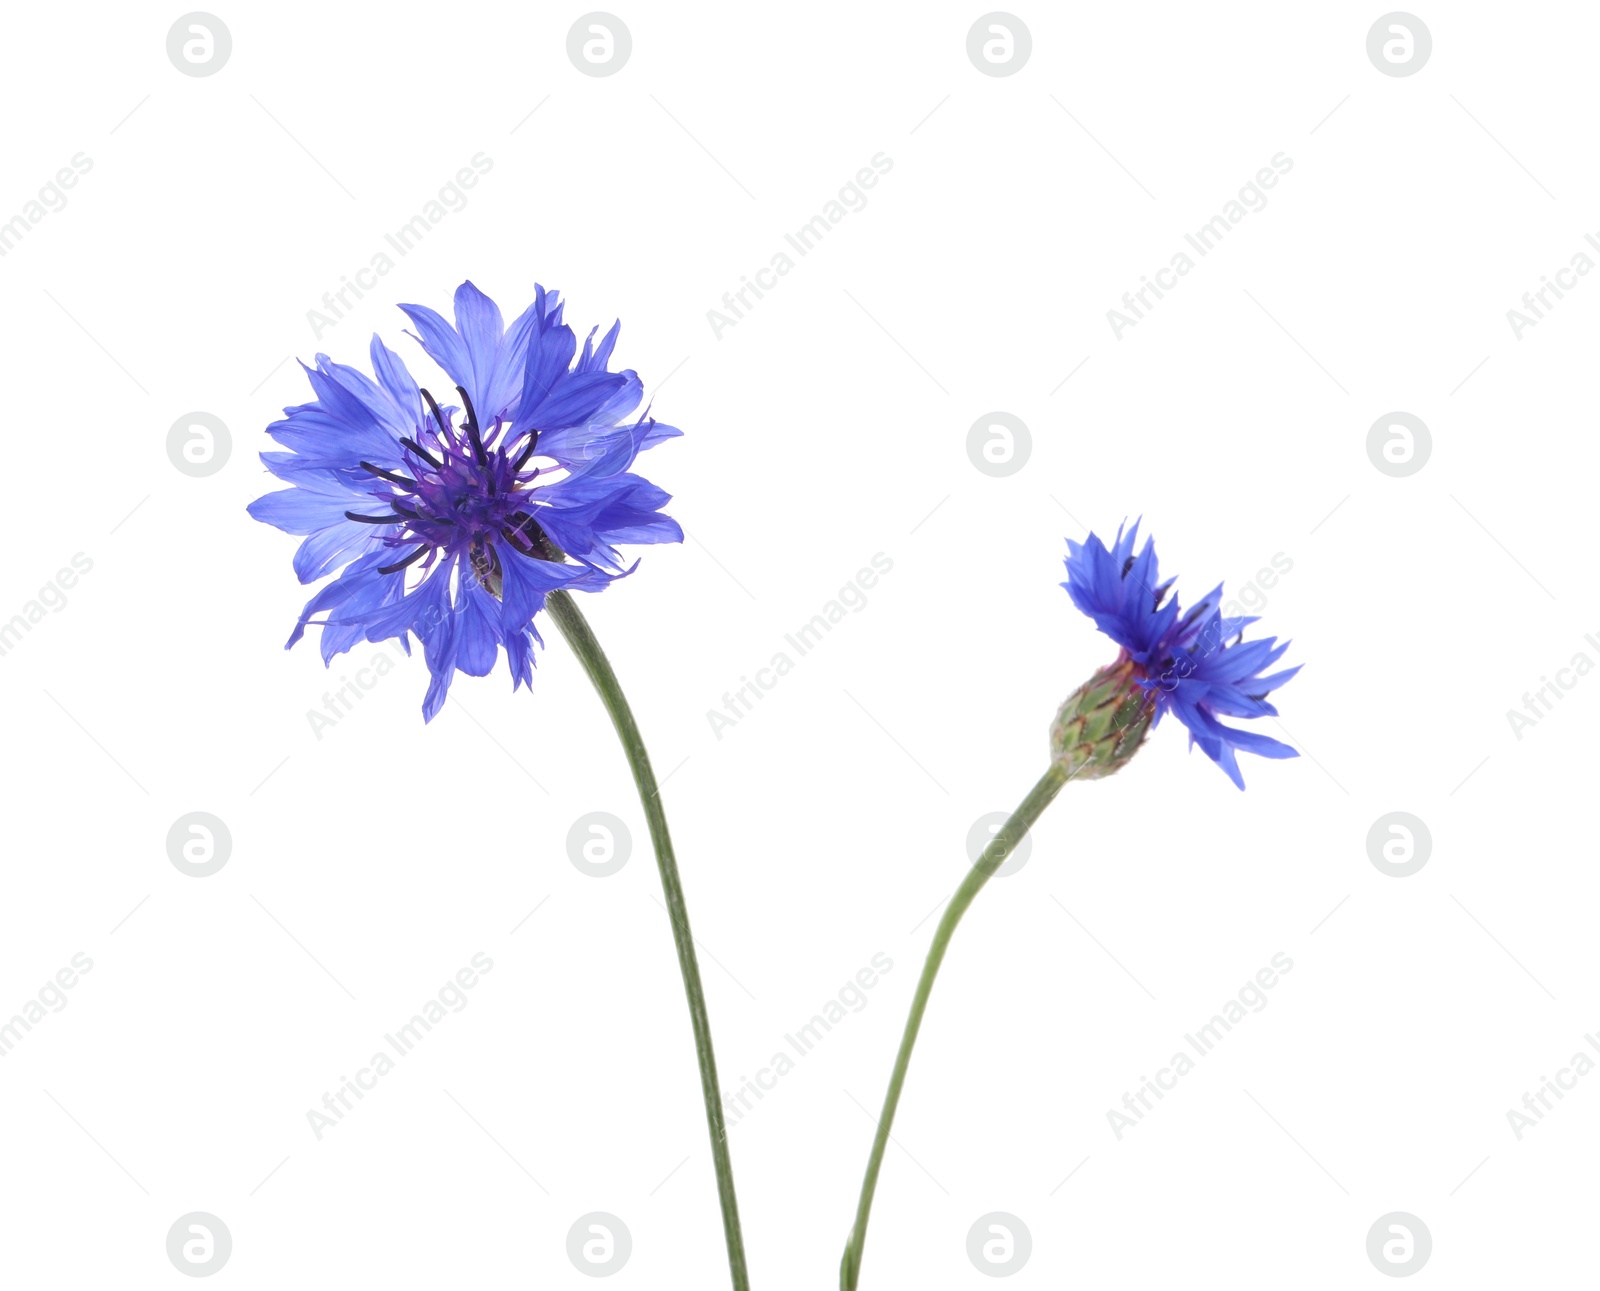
[547,592,750,1291]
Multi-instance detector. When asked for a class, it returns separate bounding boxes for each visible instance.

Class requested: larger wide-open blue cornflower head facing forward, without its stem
[250,282,683,720]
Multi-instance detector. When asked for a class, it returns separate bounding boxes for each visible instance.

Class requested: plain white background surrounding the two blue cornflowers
[0,0,1600,1288]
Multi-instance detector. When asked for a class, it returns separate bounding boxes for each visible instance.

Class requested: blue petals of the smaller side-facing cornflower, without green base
[1061,522,1299,789]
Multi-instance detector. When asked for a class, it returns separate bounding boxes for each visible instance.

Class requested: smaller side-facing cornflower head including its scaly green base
[1051,523,1299,789]
